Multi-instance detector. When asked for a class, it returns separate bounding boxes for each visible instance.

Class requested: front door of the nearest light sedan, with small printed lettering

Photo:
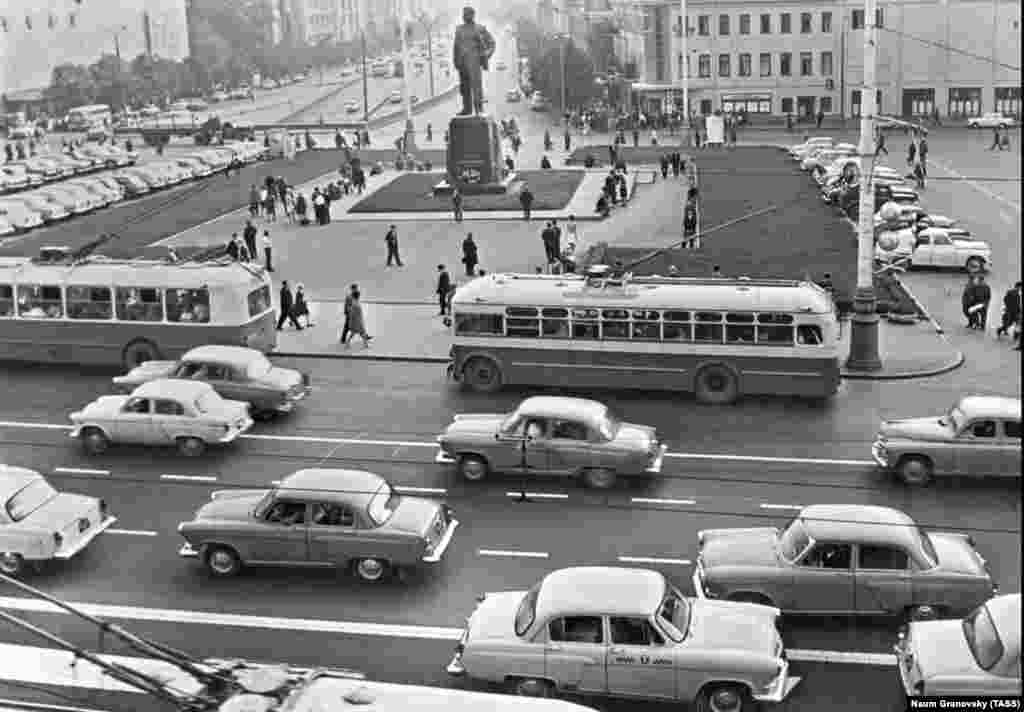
[607,616,676,700]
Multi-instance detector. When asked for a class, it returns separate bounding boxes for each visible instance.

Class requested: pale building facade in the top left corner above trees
[0,0,188,100]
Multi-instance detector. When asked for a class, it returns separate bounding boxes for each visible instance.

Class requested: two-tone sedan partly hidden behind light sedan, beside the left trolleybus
[114,345,310,419]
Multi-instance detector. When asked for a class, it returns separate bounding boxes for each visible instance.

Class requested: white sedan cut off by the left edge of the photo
[0,465,117,576]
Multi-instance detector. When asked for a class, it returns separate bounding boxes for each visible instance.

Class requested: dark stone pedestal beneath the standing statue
[434,115,515,196]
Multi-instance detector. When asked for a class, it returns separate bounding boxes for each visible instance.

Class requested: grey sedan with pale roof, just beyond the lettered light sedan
[693,504,997,617]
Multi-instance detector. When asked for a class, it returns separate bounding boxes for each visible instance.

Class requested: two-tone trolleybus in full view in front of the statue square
[449,265,840,404]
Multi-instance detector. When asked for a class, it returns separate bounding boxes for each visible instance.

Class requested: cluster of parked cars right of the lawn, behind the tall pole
[790,136,991,273]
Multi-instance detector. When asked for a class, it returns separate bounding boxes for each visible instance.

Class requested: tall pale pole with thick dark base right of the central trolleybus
[846,0,882,371]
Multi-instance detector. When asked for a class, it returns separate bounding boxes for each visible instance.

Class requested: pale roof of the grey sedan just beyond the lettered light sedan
[798,504,921,551]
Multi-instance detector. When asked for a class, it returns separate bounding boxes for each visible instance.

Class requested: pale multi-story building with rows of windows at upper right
[598,0,1021,117]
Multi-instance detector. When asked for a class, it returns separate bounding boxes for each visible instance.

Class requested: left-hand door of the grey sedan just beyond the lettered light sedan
[793,541,856,612]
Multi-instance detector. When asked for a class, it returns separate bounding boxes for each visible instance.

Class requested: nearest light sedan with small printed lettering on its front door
[446,567,800,712]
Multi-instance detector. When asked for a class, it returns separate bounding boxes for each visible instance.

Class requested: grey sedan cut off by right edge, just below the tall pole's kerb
[871,395,1021,485]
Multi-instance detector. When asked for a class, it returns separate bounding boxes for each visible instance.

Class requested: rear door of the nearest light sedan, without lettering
[544,616,607,694]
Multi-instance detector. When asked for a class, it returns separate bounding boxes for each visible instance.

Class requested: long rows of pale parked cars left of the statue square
[0,141,265,236]
